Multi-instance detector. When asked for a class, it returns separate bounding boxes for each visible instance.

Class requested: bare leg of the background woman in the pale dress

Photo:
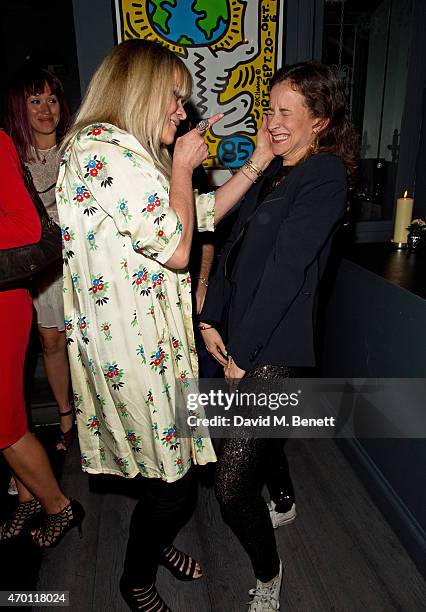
[38,325,74,450]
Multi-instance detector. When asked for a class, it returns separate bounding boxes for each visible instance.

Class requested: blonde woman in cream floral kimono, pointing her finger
[57,40,272,612]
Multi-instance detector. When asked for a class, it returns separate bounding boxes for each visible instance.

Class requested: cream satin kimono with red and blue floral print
[56,124,216,482]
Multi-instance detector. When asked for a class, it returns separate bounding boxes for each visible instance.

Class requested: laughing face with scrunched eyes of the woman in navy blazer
[268,81,321,165]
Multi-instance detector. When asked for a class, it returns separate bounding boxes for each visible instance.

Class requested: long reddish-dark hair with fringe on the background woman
[5,65,70,162]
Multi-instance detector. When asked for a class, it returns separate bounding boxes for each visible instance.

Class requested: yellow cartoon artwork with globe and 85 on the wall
[116,0,284,169]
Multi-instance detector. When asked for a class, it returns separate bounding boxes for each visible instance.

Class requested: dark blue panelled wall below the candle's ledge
[323,260,426,571]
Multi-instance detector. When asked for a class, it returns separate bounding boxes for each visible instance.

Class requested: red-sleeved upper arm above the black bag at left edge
[0,134,41,249]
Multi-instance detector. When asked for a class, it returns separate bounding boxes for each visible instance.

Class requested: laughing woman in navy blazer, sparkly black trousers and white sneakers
[200,62,357,612]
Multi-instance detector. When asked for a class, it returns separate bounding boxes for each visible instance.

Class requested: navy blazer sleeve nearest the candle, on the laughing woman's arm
[228,156,346,370]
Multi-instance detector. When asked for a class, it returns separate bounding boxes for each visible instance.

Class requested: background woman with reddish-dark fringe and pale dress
[6,66,74,450]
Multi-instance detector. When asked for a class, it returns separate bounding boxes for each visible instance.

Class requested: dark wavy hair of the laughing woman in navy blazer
[270,62,358,185]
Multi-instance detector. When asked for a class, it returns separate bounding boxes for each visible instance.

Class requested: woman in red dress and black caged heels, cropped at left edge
[0,131,84,547]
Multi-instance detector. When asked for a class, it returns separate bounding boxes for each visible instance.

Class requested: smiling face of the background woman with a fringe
[27,83,61,149]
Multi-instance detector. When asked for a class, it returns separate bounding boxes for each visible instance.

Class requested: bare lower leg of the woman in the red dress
[2,431,69,514]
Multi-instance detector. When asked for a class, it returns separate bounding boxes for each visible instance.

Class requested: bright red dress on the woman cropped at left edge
[0,130,41,449]
